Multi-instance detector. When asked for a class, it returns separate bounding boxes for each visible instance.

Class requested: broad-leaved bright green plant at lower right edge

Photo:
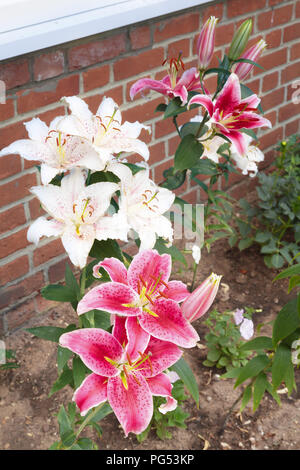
[222,263,300,412]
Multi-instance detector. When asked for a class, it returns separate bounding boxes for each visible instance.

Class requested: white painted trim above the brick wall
[0,0,213,60]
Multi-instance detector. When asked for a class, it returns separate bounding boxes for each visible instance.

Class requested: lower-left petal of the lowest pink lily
[73,374,107,416]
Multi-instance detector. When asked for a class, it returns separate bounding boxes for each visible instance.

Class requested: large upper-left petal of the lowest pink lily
[59,328,123,377]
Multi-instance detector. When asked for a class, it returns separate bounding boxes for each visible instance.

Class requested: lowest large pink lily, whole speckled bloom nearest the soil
[60,318,182,436]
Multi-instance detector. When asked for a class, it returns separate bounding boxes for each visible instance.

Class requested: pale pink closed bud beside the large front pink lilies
[181,273,222,322]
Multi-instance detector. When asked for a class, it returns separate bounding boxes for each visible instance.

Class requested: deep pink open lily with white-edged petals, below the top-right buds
[189,73,272,155]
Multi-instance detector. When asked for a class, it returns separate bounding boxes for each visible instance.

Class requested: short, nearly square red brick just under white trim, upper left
[33,51,65,81]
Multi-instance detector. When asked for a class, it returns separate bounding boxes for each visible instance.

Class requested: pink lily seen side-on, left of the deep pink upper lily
[130,55,201,105]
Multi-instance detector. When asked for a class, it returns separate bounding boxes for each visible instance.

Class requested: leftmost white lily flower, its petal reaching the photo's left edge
[0,116,102,184]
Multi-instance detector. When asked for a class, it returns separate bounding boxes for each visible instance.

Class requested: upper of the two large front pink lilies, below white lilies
[77,250,199,348]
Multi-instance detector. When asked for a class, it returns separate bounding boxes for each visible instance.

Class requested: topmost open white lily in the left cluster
[62,96,150,168]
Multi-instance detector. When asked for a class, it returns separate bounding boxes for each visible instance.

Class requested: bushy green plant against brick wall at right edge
[236,135,300,269]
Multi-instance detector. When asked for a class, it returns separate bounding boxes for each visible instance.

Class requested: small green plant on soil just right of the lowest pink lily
[137,380,189,442]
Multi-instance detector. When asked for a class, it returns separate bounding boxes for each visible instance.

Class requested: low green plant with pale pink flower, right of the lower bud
[203,307,255,371]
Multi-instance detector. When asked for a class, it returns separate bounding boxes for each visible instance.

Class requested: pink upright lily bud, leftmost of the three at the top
[197,16,219,70]
